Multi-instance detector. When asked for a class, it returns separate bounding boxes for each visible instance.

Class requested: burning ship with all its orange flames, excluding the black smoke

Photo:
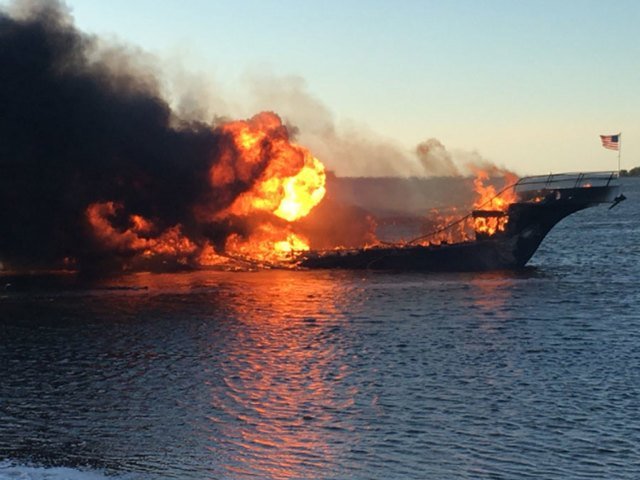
[0,97,624,274]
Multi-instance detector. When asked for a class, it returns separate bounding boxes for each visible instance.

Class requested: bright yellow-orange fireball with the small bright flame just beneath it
[210,112,326,262]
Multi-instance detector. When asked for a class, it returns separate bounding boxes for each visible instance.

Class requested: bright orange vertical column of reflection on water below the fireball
[205,272,356,479]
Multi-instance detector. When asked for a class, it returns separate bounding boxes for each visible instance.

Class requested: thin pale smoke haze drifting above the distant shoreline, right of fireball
[240,70,516,177]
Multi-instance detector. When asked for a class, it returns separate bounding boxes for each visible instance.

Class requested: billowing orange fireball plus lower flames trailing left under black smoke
[85,112,325,266]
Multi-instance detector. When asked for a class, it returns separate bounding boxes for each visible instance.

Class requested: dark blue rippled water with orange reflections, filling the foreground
[0,182,640,480]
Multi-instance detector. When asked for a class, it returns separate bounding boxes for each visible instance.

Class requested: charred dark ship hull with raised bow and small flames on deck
[298,172,624,271]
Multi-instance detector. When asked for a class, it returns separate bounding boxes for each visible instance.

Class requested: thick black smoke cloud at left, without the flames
[0,2,268,268]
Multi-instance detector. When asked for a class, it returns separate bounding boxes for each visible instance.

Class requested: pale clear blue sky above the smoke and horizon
[2,0,640,174]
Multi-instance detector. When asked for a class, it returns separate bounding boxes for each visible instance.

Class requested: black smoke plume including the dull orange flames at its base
[0,2,318,269]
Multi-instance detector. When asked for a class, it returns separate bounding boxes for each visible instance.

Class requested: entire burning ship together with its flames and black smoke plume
[0,2,624,274]
